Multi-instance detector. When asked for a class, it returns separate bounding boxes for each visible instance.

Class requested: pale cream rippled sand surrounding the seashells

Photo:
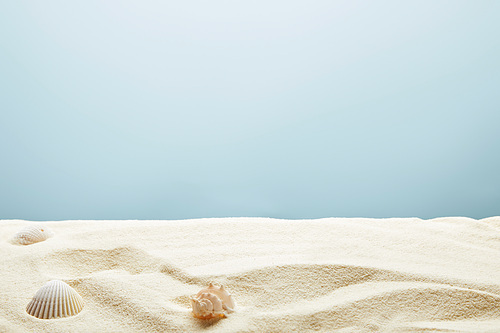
[0,217,500,332]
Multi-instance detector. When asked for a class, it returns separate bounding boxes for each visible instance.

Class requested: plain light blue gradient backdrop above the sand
[0,0,500,220]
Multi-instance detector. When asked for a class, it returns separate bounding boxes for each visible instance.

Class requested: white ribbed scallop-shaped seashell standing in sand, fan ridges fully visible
[26,280,83,319]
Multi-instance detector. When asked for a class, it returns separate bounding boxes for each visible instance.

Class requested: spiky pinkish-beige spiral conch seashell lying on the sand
[191,283,236,319]
